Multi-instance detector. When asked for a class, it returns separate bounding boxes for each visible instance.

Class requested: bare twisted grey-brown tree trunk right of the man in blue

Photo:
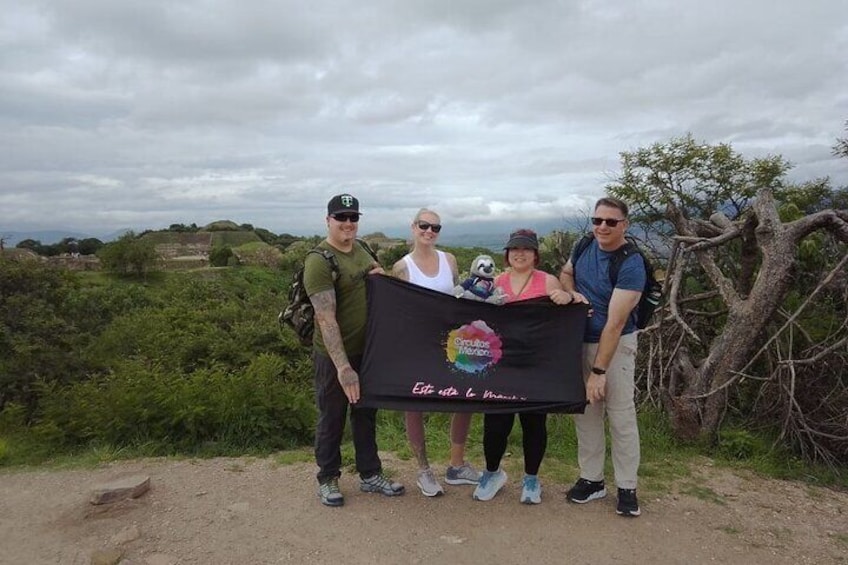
[663,189,848,439]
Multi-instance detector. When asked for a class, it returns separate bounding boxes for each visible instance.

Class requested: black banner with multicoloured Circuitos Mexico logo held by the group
[359,275,588,413]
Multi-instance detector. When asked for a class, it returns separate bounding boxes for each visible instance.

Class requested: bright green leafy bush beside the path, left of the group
[35,355,315,452]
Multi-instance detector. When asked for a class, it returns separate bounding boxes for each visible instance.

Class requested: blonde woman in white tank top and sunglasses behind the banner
[392,208,480,496]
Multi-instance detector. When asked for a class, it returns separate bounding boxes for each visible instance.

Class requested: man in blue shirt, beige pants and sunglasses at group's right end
[560,198,646,517]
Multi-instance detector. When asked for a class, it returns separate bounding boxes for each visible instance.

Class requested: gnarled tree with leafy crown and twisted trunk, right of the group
[607,135,848,450]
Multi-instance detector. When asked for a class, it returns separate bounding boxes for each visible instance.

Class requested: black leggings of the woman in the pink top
[483,412,548,475]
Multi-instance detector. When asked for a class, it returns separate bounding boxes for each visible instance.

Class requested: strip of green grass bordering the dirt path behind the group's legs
[0,410,848,498]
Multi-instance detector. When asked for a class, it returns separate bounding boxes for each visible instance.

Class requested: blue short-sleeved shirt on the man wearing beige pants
[572,239,647,343]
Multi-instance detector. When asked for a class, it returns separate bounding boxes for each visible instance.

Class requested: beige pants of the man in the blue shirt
[574,333,640,489]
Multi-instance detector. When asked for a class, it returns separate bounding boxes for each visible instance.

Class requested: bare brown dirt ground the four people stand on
[0,454,848,565]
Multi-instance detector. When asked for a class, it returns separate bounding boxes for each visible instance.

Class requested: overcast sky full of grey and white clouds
[0,0,848,238]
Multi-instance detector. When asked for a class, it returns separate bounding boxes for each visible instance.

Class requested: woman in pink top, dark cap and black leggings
[473,229,579,504]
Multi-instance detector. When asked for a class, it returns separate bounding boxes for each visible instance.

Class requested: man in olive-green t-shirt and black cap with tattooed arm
[303,194,404,506]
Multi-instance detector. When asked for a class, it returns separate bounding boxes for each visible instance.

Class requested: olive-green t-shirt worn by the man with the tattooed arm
[303,241,374,356]
